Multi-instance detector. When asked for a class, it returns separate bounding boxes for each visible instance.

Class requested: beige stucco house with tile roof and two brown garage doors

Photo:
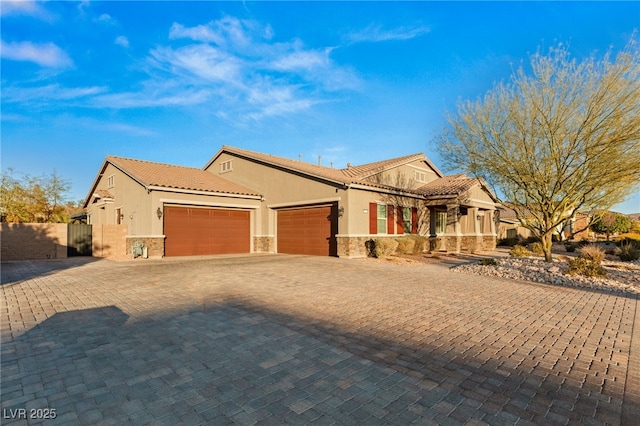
[85,146,496,257]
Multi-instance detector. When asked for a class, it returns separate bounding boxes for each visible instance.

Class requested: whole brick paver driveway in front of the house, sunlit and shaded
[0,255,640,425]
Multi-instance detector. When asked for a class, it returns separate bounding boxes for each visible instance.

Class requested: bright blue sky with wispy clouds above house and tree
[0,1,640,213]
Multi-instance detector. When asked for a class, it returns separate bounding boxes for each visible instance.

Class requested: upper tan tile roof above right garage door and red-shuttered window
[223,146,436,188]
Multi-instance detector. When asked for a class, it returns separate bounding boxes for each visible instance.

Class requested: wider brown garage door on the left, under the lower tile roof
[164,206,251,256]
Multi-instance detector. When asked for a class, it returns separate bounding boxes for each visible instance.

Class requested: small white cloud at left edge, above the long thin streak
[0,40,73,68]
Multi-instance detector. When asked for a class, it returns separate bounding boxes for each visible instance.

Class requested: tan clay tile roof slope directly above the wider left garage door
[107,156,260,196]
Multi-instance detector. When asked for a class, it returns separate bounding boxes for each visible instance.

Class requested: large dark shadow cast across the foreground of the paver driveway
[2,297,640,425]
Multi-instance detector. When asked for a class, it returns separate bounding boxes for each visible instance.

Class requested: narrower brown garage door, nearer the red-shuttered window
[277,204,338,256]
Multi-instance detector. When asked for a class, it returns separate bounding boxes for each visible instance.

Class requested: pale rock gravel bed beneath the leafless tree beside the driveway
[452,257,640,295]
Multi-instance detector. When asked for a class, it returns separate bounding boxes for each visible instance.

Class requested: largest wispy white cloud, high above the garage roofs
[134,16,359,120]
